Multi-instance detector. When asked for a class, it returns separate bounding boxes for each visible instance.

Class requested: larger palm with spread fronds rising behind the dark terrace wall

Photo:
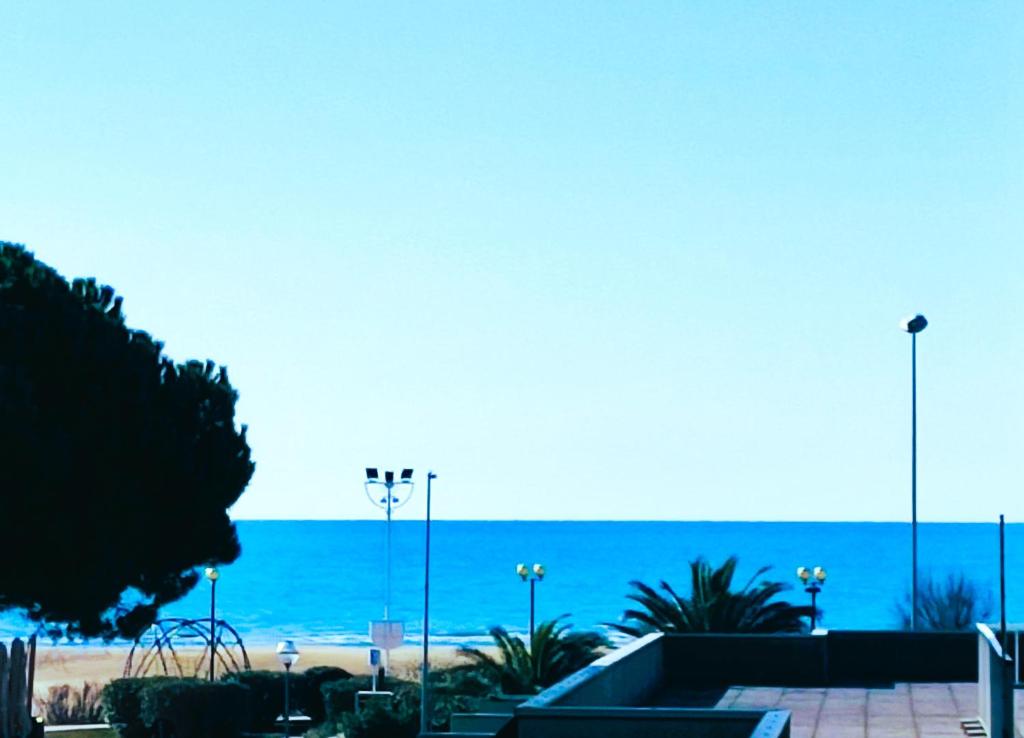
[607,556,811,637]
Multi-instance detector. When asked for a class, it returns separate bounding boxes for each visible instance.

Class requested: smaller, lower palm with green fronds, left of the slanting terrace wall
[460,615,610,694]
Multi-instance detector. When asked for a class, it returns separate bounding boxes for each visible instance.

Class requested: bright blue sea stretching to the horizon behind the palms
[3,520,1024,645]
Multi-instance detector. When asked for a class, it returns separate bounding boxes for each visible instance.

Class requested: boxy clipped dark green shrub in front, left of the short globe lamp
[139,679,251,738]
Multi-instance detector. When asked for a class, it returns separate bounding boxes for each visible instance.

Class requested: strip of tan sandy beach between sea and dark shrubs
[35,645,475,696]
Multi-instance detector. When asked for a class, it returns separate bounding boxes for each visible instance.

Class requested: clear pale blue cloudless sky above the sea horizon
[0,0,1024,520]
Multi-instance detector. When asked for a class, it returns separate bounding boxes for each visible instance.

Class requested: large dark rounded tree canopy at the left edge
[0,242,254,638]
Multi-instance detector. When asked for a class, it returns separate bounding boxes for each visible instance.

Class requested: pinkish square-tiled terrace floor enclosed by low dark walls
[717,683,1024,738]
